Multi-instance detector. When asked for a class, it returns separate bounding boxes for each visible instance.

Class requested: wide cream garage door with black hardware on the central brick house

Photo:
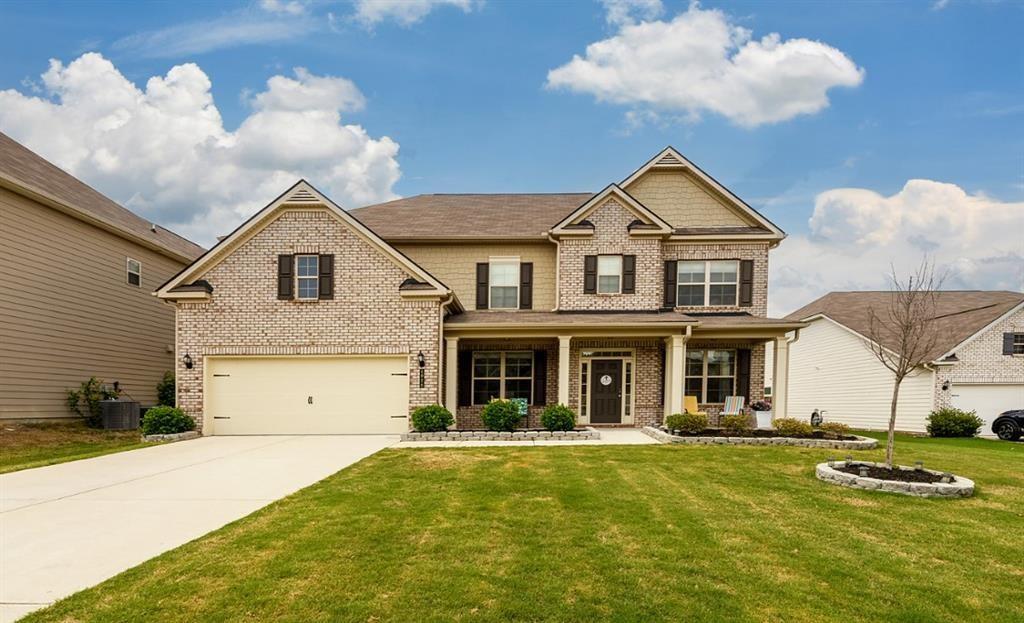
[206,357,409,434]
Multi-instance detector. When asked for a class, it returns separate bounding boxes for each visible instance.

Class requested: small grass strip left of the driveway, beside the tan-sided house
[0,422,151,473]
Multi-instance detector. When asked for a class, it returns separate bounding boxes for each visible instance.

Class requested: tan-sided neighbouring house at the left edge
[0,133,203,419]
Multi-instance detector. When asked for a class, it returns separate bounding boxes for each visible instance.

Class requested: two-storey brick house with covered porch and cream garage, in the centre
[157,148,803,434]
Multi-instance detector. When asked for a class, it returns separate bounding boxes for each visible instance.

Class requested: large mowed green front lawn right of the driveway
[28,438,1024,622]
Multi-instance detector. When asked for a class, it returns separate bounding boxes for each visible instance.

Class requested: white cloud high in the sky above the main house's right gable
[547,2,864,127]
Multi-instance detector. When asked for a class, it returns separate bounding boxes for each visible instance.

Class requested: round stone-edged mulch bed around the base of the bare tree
[814,461,974,498]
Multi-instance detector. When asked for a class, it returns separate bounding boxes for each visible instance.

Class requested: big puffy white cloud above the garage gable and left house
[0,53,400,244]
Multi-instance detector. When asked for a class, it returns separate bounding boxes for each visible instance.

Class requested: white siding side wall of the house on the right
[790,319,934,432]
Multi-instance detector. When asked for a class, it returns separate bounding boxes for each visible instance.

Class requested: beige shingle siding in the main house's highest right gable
[626,169,759,229]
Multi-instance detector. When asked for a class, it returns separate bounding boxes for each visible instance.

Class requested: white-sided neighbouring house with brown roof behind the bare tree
[787,291,1024,435]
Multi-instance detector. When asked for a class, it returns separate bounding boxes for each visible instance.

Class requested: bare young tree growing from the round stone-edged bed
[867,257,944,467]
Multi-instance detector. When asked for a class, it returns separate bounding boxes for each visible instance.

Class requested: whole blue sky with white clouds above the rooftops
[0,0,1024,309]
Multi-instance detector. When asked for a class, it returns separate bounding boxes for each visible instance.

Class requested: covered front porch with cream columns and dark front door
[444,313,792,428]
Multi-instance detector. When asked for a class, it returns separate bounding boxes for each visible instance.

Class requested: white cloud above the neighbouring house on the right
[770,179,1024,315]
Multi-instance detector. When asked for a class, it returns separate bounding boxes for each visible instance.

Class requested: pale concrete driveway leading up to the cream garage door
[0,435,398,622]
